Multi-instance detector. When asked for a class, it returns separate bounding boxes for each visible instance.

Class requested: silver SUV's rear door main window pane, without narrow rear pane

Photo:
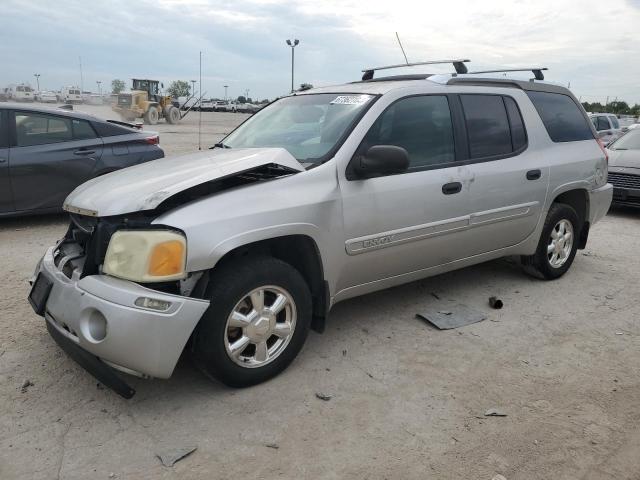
[460,95,513,158]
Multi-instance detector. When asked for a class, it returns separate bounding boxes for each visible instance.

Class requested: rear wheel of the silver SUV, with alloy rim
[521,203,582,280]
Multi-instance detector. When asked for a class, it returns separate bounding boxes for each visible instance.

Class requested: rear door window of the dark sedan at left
[15,113,73,147]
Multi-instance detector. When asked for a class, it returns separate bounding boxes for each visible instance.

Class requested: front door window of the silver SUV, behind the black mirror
[361,95,455,169]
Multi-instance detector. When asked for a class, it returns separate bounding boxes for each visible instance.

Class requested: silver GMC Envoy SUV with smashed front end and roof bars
[29,62,612,397]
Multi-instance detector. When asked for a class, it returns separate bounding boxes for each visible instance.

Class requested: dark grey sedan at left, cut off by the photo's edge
[0,103,164,216]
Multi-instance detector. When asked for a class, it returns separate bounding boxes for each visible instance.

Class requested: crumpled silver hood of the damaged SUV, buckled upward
[64,148,304,217]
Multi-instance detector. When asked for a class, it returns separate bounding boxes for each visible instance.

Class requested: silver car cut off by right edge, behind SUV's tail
[607,128,640,207]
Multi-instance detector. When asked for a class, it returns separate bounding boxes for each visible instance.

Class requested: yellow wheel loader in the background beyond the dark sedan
[113,78,182,125]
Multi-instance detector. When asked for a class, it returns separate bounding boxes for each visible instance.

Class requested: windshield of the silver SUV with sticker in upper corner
[223,93,375,163]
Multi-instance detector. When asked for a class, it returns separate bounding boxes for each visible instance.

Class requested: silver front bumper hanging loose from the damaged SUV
[39,248,209,378]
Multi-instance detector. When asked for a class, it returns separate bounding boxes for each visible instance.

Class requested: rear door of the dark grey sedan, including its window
[10,111,103,211]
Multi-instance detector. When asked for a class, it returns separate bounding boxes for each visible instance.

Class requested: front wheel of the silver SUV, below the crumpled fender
[193,257,311,387]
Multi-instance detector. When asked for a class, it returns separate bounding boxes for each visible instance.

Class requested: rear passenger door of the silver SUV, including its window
[460,94,549,256]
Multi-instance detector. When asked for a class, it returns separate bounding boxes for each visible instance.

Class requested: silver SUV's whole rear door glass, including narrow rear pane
[460,95,527,159]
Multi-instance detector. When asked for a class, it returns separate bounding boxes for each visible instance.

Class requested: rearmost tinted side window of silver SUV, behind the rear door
[527,91,594,142]
